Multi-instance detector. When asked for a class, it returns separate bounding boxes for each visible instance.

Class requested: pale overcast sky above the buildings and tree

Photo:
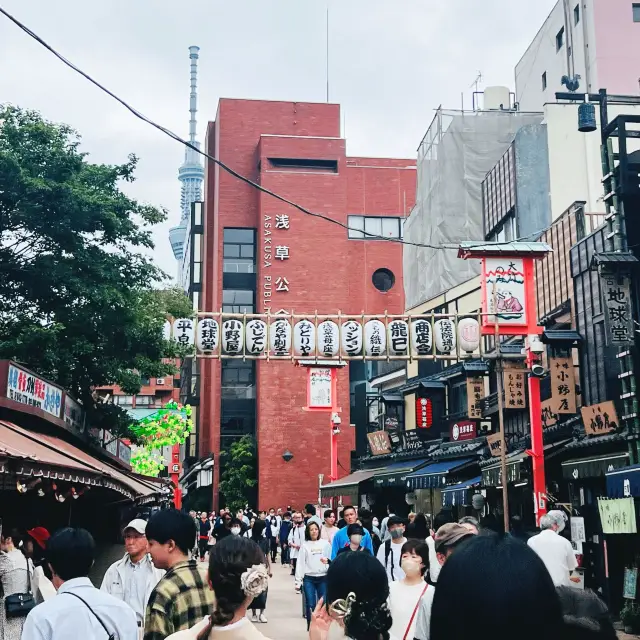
[0,0,555,276]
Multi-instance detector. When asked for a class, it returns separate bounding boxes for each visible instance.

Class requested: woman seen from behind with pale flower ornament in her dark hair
[167,536,269,640]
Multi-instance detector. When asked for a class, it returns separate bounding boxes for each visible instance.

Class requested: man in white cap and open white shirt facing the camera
[100,518,164,637]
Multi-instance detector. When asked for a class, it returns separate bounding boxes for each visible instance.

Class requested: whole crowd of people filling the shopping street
[0,504,616,640]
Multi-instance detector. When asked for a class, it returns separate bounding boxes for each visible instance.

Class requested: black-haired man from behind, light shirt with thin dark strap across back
[22,527,138,640]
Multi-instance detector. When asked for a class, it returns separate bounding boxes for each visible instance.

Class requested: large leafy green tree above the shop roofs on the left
[0,105,191,433]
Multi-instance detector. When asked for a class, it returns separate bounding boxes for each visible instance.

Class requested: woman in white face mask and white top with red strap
[389,540,429,640]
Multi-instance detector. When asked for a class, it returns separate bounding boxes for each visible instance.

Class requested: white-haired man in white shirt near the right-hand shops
[527,511,579,587]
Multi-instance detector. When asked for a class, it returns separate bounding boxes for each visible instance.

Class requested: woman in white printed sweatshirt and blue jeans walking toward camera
[296,522,331,629]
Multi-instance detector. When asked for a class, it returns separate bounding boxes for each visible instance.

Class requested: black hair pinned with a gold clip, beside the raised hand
[326,553,392,640]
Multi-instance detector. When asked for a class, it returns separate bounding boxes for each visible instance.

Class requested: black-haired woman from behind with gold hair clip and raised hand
[309,553,392,640]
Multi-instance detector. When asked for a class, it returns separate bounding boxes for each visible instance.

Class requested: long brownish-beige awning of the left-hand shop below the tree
[0,421,158,500]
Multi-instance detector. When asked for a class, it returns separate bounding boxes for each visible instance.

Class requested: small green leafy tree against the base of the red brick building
[220,436,258,513]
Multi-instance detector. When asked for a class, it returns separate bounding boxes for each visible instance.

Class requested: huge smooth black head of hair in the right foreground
[430,535,562,640]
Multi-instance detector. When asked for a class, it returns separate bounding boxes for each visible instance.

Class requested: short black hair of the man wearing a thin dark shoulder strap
[45,528,95,581]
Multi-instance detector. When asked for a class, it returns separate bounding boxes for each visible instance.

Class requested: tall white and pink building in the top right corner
[515,0,640,111]
